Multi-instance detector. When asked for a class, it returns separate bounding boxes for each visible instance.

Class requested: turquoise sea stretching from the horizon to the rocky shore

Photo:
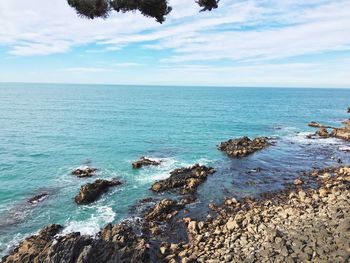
[0,84,350,256]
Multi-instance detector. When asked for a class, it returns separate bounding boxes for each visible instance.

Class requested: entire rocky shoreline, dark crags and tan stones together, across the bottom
[2,113,350,263]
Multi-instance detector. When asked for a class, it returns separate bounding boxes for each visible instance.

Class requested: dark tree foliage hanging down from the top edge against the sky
[68,0,219,23]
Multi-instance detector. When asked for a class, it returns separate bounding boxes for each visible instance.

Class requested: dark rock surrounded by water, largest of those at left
[75,179,121,204]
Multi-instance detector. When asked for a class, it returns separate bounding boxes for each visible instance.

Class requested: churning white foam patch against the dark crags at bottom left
[62,206,116,235]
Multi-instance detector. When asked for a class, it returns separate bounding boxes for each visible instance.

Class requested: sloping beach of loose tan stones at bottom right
[159,167,350,262]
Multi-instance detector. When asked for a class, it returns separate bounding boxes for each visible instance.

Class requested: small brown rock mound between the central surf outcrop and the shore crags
[144,199,183,222]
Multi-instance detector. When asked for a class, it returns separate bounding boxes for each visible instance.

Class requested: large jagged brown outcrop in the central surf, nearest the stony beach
[151,164,215,194]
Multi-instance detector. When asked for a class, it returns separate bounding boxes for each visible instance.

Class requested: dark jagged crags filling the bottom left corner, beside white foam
[2,224,148,263]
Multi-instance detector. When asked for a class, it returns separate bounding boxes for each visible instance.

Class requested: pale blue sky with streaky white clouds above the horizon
[0,0,350,88]
